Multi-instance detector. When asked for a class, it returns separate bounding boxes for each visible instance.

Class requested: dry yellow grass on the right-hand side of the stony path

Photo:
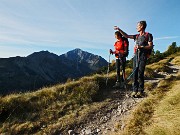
[118,53,180,135]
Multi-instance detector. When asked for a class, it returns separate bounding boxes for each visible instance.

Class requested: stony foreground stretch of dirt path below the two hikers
[76,93,143,135]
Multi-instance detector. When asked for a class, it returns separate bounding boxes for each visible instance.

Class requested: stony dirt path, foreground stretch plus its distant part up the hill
[69,63,180,135]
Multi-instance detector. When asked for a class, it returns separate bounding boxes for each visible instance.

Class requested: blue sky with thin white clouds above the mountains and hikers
[0,0,180,60]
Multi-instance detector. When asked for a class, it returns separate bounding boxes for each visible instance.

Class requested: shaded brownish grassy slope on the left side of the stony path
[0,52,178,134]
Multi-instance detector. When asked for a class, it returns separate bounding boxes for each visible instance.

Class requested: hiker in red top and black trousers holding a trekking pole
[110,31,128,88]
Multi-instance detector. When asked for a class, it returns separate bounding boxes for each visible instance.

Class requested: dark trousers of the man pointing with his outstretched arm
[133,54,147,92]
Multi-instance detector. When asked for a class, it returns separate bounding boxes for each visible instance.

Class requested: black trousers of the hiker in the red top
[116,57,126,82]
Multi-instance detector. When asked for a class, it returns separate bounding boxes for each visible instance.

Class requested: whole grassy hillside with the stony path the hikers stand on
[0,48,180,135]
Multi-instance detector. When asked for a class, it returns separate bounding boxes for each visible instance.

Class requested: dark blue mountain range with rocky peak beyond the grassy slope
[0,49,107,95]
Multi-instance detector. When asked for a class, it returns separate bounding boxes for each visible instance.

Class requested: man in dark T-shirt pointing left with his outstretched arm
[114,21,153,97]
